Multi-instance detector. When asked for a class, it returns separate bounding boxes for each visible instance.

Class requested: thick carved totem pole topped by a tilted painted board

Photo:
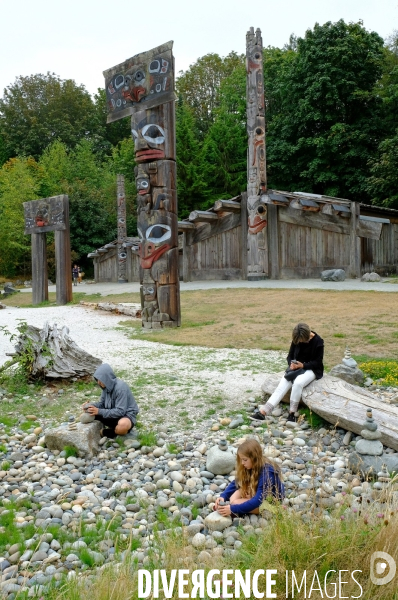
[104,42,181,329]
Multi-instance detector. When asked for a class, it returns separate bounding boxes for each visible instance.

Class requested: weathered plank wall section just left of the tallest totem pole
[190,225,242,281]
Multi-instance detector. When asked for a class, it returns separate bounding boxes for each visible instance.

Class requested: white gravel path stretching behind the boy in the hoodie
[0,306,285,425]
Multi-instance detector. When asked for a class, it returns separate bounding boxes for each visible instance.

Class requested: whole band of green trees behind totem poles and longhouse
[0,20,398,275]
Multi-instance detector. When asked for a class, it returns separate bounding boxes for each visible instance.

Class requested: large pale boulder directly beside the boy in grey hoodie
[45,421,103,458]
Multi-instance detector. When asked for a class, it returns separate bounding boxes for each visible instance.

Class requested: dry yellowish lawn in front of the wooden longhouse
[3,288,398,368]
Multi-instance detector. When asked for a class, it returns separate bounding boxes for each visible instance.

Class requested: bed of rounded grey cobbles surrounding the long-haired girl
[0,398,398,599]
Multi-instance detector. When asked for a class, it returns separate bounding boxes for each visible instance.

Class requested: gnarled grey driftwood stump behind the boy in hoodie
[7,322,102,379]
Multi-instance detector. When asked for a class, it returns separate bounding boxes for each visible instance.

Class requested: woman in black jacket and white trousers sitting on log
[252,323,323,422]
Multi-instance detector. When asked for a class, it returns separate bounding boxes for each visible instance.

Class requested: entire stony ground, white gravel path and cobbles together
[0,307,398,600]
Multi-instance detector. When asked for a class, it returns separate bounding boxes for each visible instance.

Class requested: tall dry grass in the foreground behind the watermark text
[38,497,398,600]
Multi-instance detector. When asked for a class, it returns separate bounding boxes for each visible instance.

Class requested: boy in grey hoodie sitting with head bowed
[86,363,139,438]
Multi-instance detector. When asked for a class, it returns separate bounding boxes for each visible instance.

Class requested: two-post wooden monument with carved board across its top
[23,196,72,305]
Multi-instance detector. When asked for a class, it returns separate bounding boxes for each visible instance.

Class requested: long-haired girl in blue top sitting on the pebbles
[213,439,285,517]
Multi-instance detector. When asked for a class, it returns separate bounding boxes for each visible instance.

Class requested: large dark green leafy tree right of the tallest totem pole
[267,20,383,201]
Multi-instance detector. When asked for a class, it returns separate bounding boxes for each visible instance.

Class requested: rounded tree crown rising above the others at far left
[0,73,97,158]
